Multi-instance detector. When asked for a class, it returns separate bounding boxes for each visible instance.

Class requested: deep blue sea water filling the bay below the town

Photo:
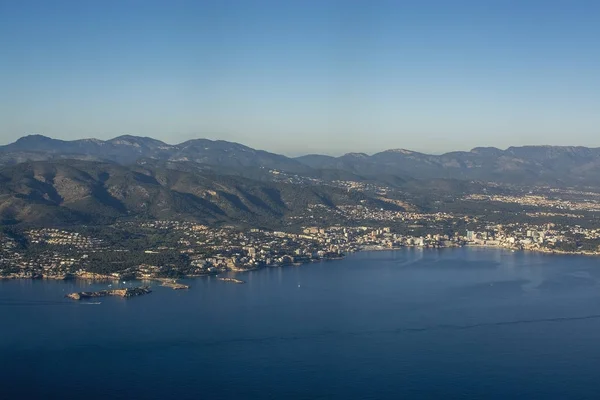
[0,248,600,399]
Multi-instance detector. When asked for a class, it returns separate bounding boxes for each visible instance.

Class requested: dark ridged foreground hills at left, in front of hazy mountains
[0,160,402,227]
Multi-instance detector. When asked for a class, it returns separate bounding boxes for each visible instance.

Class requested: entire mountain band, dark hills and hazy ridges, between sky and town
[0,135,600,227]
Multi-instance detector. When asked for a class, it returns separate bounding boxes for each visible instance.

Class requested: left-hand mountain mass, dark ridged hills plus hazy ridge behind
[0,135,401,227]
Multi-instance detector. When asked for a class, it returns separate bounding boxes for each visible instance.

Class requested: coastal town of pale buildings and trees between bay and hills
[0,186,600,282]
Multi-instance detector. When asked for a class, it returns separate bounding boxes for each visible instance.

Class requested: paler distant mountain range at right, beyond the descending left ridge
[297,146,600,186]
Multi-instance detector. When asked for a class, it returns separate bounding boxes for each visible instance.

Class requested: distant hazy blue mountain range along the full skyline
[0,135,600,185]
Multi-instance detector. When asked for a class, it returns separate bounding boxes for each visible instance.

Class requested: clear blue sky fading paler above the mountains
[0,0,600,155]
